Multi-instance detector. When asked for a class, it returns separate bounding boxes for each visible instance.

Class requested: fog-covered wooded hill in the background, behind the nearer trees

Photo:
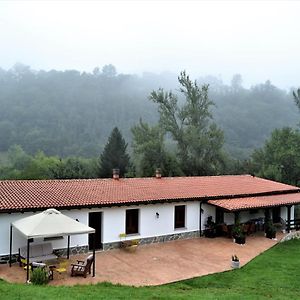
[0,64,299,157]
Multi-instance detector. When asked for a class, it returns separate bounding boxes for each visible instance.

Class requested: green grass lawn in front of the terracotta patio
[0,240,300,300]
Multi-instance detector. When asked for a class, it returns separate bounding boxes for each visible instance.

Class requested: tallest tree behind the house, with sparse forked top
[150,72,224,175]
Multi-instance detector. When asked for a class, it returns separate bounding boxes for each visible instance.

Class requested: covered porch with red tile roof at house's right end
[205,193,300,237]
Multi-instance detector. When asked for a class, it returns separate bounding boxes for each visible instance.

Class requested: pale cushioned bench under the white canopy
[19,243,57,263]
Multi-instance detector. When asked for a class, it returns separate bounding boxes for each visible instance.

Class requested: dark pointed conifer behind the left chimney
[99,127,130,178]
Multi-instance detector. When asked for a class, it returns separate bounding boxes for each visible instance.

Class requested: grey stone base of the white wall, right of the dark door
[103,230,200,251]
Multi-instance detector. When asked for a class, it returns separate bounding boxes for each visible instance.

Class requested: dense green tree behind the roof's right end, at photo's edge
[252,127,300,185]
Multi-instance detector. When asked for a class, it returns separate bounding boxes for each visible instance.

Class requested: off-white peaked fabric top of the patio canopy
[12,208,95,239]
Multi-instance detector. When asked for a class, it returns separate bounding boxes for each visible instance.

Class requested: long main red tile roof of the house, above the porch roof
[0,175,300,212]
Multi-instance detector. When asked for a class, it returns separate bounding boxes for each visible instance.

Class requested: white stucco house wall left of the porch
[0,201,200,255]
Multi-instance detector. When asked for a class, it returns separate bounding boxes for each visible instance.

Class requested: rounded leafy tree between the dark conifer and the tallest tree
[131,120,182,177]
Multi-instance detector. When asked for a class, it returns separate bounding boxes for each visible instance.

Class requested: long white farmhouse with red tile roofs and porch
[0,175,300,256]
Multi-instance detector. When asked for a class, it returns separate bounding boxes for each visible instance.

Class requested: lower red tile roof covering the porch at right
[208,193,300,212]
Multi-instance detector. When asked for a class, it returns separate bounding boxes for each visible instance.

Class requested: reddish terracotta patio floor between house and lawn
[0,233,283,286]
